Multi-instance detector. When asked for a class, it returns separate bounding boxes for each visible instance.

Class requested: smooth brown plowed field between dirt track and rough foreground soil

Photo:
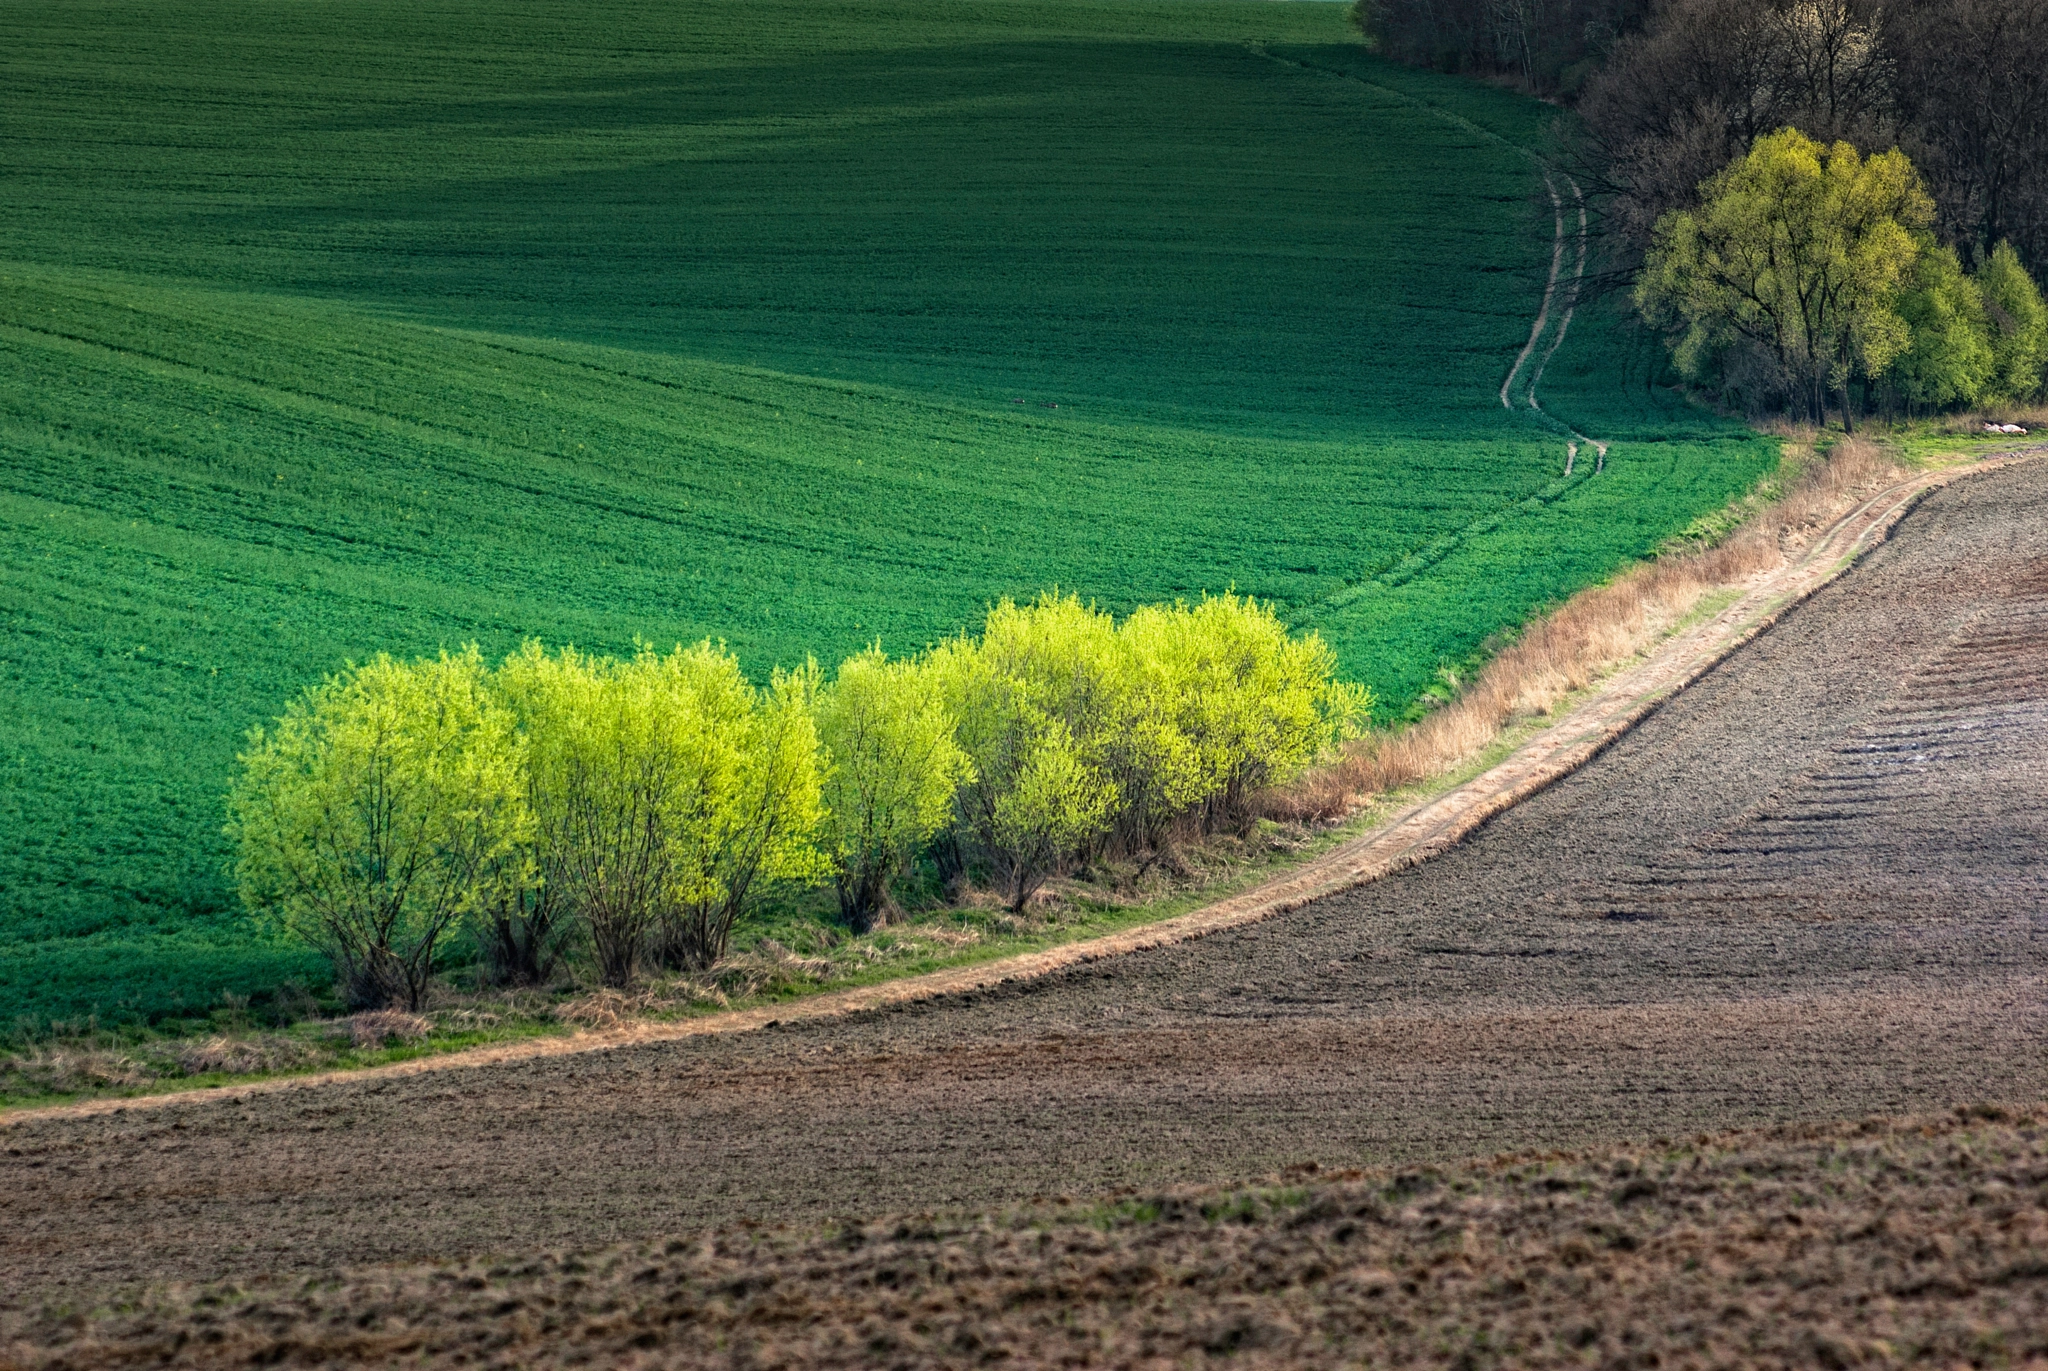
[0,463,2048,1303]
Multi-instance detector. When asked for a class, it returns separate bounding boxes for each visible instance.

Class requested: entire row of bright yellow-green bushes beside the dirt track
[227,594,1372,1008]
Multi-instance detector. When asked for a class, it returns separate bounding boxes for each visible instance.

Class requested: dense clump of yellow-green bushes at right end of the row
[926,592,1372,908]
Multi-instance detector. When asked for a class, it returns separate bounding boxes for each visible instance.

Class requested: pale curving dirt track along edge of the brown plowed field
[0,447,2048,1127]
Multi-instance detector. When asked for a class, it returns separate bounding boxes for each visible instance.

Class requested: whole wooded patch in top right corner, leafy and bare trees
[1358,0,2048,426]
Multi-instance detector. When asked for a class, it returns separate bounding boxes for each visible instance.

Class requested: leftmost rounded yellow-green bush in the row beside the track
[229,648,530,1008]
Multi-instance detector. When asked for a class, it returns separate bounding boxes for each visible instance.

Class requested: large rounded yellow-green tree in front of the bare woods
[1636,129,1933,428]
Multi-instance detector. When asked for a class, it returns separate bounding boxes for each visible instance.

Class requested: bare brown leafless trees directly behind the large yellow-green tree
[1577,0,2048,275]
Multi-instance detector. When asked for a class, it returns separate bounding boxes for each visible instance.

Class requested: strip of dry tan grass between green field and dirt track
[1262,434,1907,820]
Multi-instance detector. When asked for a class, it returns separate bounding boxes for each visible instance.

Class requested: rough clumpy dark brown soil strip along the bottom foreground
[0,1107,2048,1371]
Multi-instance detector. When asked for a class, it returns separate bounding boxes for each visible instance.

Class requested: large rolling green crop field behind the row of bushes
[0,0,1774,1023]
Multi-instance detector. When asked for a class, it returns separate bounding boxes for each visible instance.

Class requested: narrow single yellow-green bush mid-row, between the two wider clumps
[813,648,969,932]
